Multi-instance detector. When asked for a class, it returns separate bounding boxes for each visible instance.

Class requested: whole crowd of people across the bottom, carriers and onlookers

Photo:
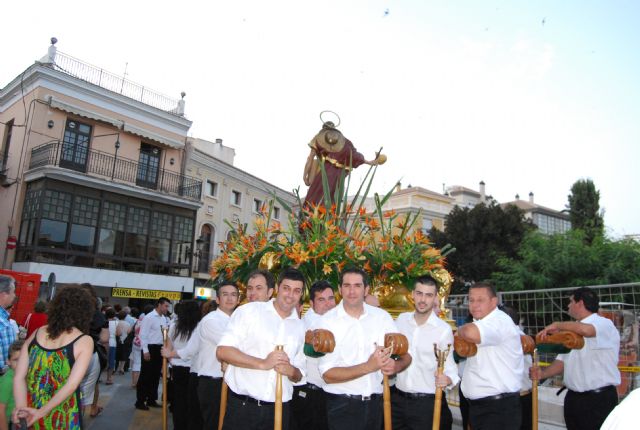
[0,268,637,430]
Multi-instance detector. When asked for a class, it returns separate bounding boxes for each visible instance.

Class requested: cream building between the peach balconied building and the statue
[186,138,297,297]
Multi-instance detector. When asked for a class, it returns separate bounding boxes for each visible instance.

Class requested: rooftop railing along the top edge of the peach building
[55,51,184,115]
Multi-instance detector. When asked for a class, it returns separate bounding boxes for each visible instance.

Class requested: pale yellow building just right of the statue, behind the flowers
[363,182,455,232]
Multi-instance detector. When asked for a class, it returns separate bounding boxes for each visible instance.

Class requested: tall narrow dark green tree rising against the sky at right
[567,179,604,244]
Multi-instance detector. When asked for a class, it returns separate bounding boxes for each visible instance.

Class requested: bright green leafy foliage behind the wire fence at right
[492,230,640,291]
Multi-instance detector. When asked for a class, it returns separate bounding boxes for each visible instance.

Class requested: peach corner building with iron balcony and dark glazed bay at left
[0,39,202,303]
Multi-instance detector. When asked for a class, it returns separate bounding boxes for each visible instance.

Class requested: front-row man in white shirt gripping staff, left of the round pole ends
[216,268,304,430]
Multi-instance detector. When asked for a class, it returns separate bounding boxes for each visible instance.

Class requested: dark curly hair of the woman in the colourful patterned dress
[47,285,95,339]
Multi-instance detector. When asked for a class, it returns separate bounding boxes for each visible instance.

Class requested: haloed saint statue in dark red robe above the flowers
[303,121,387,207]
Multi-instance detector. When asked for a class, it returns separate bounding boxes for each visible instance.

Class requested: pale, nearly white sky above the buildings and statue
[0,0,640,237]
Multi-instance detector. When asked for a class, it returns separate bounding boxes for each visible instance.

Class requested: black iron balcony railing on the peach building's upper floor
[29,140,202,201]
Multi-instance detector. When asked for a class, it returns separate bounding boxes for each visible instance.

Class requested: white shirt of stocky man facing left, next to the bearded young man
[462,308,524,400]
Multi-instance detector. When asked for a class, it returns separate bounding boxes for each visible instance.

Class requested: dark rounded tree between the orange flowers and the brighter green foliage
[429,202,533,292]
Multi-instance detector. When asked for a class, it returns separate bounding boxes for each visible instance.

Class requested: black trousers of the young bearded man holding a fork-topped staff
[391,387,453,430]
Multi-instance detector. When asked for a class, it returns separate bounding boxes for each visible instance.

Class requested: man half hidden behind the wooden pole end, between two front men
[291,281,336,430]
